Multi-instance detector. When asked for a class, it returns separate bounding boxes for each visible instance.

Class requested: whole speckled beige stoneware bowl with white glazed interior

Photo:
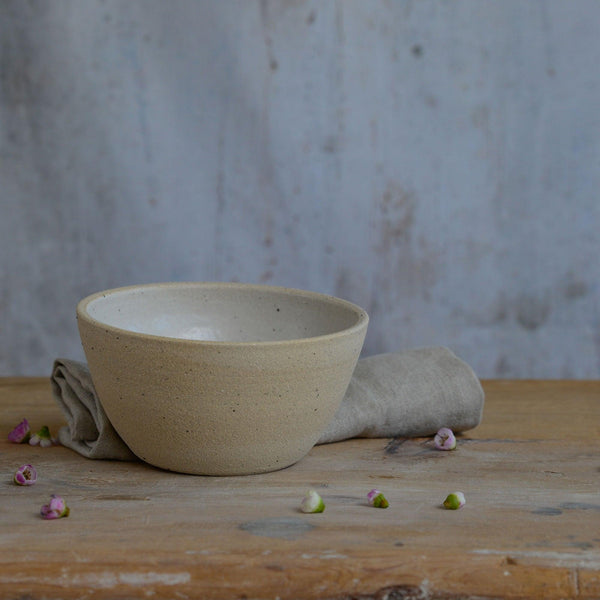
[77,283,369,475]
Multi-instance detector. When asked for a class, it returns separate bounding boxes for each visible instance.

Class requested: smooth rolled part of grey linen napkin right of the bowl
[319,348,484,444]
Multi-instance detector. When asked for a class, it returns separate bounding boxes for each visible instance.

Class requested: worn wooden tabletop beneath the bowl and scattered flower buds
[0,378,600,600]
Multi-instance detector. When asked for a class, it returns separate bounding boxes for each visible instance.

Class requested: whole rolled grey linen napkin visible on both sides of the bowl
[51,347,484,460]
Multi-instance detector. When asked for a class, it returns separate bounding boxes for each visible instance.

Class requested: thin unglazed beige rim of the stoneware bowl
[76,281,369,347]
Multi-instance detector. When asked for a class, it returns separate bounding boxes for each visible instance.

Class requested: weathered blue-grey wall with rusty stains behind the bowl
[0,0,600,378]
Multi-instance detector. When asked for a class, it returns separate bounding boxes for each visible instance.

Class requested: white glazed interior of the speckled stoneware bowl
[85,284,362,343]
